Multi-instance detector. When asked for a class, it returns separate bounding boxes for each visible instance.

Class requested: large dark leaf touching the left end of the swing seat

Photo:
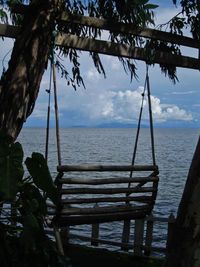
[25,153,59,205]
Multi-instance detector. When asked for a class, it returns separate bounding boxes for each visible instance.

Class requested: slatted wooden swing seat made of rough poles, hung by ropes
[48,165,159,227]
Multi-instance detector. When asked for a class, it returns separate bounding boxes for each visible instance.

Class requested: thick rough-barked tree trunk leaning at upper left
[0,1,55,140]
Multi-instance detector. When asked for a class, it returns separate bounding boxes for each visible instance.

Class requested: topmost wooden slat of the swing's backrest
[57,165,158,172]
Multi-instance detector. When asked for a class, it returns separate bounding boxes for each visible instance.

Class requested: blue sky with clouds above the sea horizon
[0,0,200,128]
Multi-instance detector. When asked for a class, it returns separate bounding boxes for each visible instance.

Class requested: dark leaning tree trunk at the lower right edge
[165,139,200,267]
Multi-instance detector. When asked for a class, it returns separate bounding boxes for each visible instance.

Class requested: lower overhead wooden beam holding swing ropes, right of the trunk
[56,33,200,70]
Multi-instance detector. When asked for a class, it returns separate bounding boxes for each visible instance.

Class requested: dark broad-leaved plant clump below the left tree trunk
[0,133,69,267]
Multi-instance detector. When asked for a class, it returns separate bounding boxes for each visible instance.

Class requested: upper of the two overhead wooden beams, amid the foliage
[60,12,200,48]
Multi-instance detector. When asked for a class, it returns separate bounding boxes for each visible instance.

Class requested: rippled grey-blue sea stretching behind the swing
[17,128,200,258]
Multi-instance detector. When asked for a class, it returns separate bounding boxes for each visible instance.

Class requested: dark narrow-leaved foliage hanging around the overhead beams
[0,0,200,89]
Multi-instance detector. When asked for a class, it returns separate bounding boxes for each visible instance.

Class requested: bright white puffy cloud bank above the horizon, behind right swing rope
[72,87,193,122]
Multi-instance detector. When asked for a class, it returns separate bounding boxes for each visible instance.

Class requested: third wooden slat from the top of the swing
[61,187,157,195]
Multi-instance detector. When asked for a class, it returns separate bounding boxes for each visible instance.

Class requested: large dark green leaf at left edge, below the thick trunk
[0,134,24,201]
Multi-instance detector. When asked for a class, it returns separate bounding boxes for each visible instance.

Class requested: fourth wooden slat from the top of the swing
[61,196,152,204]
